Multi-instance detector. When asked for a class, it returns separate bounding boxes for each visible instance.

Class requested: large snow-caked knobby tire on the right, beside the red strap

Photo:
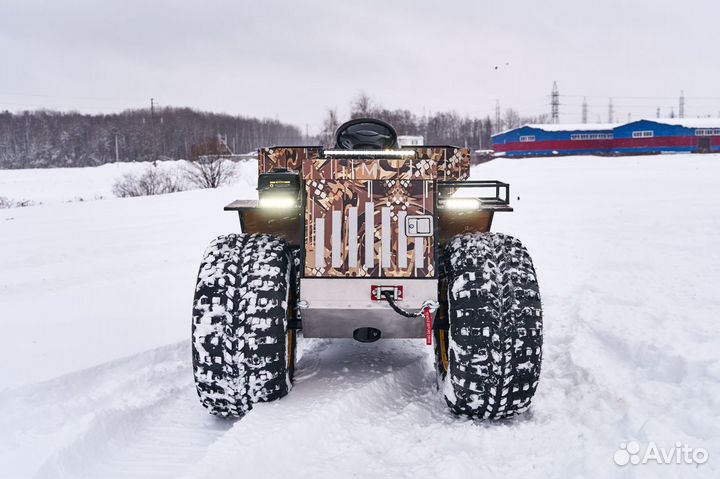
[435,233,543,419]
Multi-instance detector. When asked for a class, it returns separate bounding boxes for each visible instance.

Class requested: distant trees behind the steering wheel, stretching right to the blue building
[320,94,547,150]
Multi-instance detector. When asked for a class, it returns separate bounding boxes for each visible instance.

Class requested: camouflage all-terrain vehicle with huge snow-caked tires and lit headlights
[192,119,543,419]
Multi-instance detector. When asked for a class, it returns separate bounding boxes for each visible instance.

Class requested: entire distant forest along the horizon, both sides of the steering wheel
[0,94,544,169]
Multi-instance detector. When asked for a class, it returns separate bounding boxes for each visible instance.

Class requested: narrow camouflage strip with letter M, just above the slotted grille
[302,158,437,180]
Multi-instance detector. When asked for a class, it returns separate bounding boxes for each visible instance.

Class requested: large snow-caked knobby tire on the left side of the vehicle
[192,234,296,417]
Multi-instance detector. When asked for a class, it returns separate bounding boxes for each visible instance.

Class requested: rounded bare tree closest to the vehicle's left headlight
[185,137,235,188]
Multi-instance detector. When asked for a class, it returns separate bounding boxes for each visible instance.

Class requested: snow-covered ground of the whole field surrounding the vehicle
[0,155,720,477]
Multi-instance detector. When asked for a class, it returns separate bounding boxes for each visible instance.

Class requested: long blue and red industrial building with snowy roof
[493,118,720,157]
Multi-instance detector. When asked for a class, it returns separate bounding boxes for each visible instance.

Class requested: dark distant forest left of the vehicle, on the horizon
[0,108,304,168]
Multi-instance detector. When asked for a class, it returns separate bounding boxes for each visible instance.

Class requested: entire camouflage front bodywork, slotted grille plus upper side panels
[259,147,470,279]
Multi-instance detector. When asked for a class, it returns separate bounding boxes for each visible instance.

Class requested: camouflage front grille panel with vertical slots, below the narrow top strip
[305,179,435,278]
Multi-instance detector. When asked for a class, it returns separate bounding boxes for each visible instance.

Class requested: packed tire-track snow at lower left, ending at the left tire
[0,341,231,477]
